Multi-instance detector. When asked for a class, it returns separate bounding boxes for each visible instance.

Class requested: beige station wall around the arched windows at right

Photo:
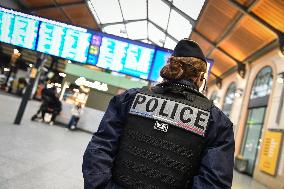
[208,49,284,189]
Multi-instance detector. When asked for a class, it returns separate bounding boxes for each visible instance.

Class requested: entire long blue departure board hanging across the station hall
[0,7,184,81]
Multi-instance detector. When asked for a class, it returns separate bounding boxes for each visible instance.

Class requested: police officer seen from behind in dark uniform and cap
[83,39,234,189]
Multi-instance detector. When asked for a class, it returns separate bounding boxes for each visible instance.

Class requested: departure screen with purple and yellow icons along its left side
[88,35,155,79]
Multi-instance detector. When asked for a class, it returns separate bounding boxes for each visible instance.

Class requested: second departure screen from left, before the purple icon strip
[37,22,91,63]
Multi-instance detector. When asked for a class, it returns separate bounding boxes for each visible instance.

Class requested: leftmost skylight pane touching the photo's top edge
[90,0,123,24]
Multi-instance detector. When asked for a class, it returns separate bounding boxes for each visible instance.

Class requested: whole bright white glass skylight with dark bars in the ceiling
[88,0,199,45]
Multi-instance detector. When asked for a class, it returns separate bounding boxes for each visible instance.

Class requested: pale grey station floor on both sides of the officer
[0,93,267,189]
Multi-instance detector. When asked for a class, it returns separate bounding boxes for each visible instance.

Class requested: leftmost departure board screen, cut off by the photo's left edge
[0,10,39,50]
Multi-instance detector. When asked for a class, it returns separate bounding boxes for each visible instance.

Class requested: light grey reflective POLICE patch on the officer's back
[129,93,210,136]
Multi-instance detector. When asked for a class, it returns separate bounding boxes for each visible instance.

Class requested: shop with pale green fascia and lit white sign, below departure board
[57,64,148,132]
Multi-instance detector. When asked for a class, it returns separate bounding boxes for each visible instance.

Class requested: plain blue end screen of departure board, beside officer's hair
[148,50,172,81]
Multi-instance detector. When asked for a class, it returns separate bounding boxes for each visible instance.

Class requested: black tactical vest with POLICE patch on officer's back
[113,85,212,189]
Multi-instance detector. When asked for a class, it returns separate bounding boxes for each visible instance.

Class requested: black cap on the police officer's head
[172,39,206,62]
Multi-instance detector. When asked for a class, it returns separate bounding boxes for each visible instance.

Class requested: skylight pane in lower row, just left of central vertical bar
[126,21,147,39]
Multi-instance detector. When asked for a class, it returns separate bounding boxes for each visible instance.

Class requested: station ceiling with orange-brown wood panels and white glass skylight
[11,0,284,84]
